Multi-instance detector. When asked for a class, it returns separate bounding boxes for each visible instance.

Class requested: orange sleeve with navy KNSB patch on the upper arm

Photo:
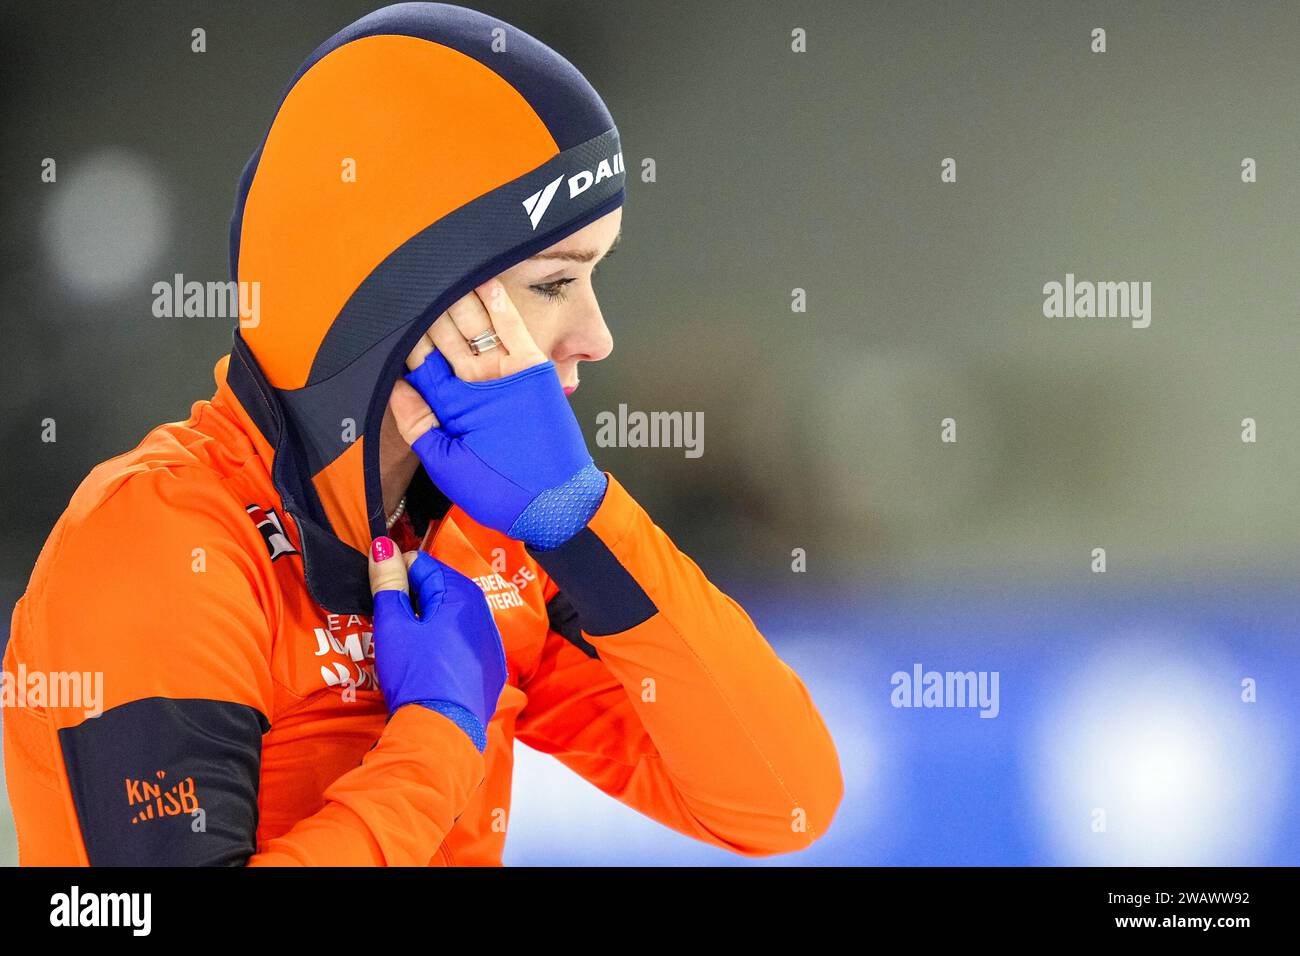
[4,468,484,866]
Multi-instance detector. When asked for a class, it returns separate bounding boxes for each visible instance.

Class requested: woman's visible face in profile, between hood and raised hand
[497,208,623,394]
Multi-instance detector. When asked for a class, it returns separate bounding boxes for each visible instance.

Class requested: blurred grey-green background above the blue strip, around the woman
[0,0,1300,868]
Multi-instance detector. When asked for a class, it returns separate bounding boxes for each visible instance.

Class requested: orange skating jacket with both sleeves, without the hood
[4,359,841,865]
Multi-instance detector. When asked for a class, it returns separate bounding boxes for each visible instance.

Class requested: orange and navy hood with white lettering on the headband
[220,3,625,614]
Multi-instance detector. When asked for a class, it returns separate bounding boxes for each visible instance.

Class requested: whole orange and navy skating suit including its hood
[3,4,842,866]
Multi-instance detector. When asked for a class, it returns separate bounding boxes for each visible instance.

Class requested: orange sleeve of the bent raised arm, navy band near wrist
[517,476,844,856]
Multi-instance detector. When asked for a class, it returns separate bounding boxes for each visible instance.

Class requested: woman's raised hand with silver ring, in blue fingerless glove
[391,280,607,550]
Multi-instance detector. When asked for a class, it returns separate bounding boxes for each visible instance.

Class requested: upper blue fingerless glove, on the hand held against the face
[406,351,608,550]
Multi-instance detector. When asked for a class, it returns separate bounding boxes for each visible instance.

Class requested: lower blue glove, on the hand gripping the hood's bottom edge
[374,551,506,753]
